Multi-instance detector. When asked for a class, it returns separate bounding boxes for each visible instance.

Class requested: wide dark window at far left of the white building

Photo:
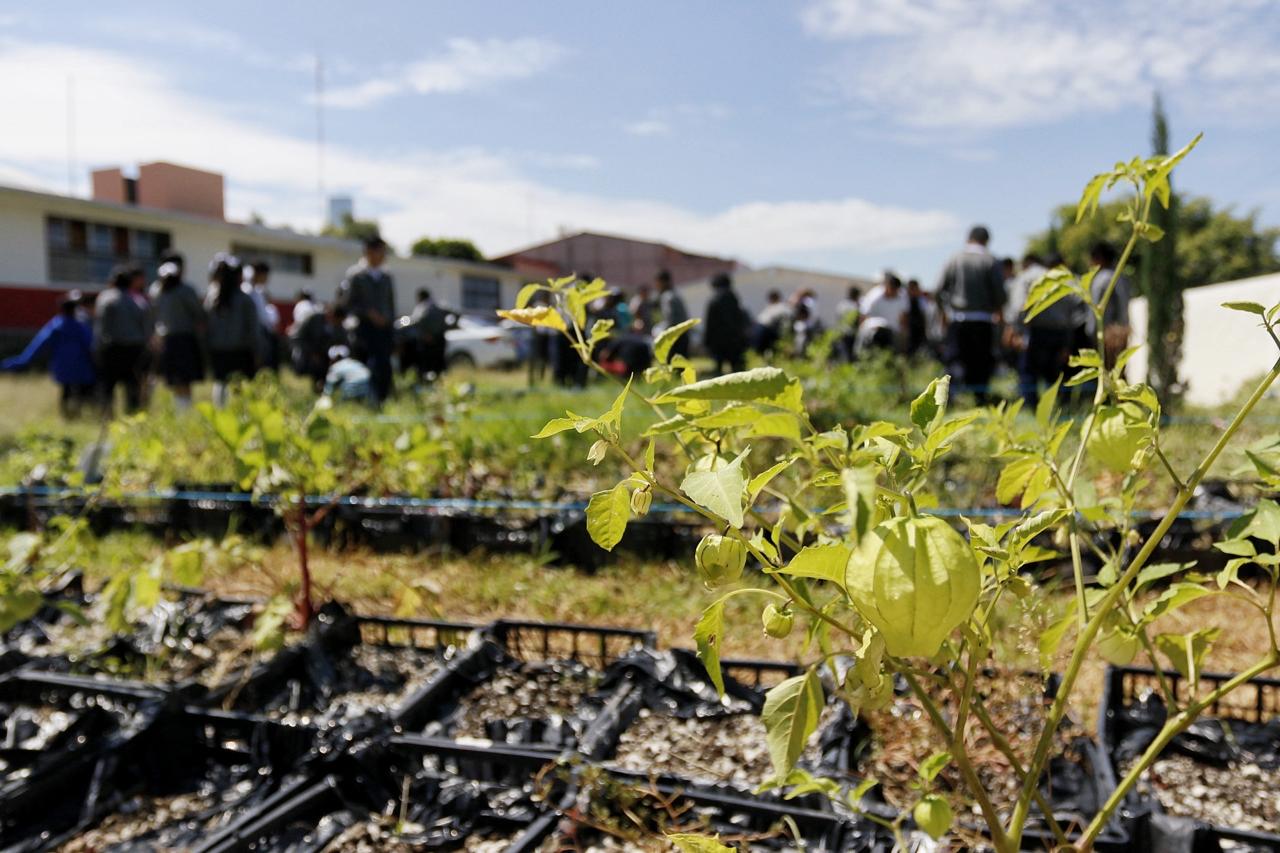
[45,216,170,284]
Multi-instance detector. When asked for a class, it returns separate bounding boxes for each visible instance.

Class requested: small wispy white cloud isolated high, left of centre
[324,38,564,108]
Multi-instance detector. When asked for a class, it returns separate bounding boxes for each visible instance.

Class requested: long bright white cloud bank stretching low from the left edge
[0,42,959,263]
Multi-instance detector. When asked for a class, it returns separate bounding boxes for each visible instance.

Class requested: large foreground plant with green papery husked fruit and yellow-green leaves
[502,138,1280,850]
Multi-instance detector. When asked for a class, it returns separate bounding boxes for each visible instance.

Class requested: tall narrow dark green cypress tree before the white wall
[1140,92,1184,405]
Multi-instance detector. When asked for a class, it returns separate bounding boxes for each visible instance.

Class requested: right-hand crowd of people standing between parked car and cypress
[532,225,1130,403]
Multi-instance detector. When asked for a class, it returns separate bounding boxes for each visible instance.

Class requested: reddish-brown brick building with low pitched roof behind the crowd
[493,231,739,289]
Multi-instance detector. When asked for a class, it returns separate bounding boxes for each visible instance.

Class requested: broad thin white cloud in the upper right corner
[801,0,1280,128]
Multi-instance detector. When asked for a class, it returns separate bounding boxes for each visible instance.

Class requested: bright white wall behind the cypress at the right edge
[1129,274,1280,406]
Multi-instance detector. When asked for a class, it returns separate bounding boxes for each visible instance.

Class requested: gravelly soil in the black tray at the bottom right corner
[1120,756,1280,833]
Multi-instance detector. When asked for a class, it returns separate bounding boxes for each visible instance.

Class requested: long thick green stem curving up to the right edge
[1010,361,1280,844]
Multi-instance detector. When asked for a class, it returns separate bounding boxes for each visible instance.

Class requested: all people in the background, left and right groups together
[0,225,1130,416]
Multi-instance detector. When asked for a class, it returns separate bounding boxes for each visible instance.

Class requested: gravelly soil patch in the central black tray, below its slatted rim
[453,667,599,738]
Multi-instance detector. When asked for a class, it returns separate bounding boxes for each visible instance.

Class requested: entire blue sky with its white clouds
[0,0,1280,282]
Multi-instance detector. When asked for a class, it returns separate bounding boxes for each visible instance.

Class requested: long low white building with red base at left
[0,163,524,341]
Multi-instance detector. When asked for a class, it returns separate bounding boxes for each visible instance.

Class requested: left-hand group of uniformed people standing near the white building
[0,238,456,418]
